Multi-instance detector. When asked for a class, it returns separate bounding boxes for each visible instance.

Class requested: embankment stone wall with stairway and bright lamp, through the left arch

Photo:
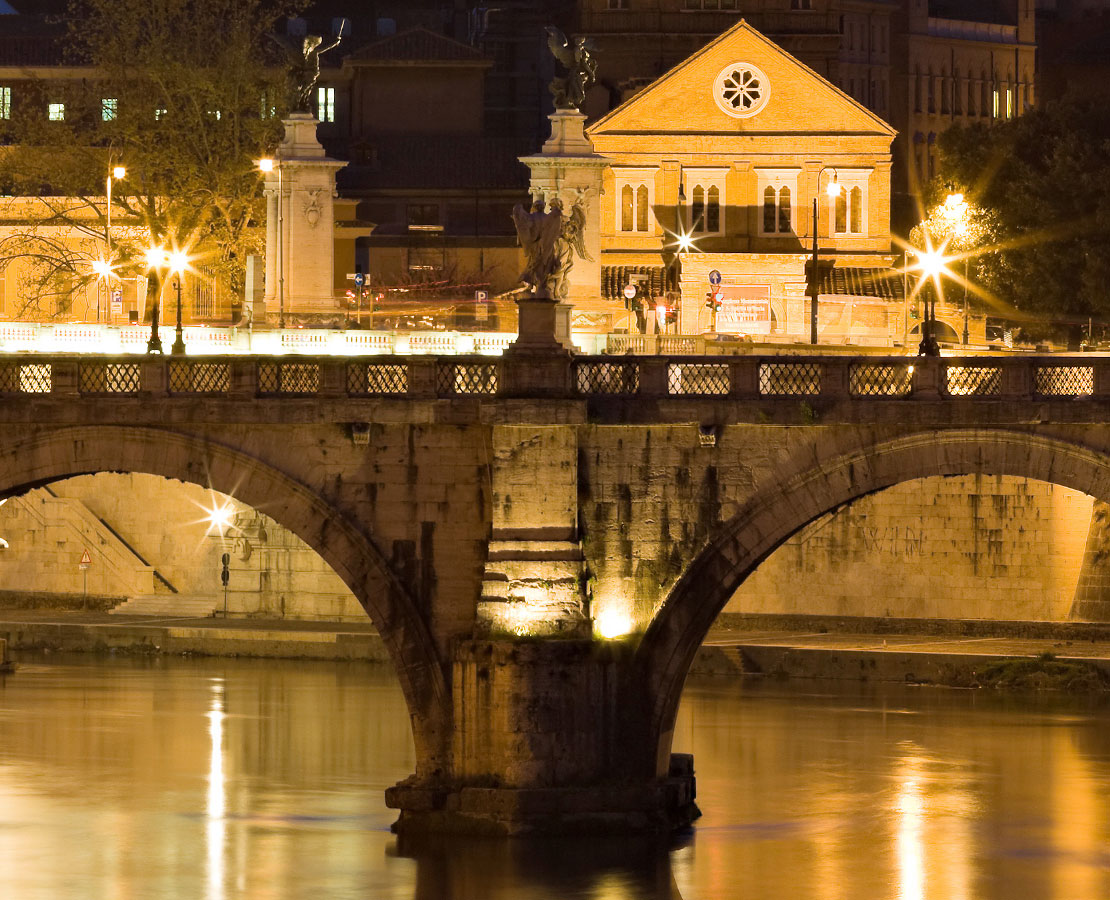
[0,473,366,620]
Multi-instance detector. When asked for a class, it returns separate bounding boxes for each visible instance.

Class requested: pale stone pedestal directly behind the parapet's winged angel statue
[521,110,608,317]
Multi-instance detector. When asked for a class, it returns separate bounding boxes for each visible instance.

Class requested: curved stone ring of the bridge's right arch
[636,428,1110,775]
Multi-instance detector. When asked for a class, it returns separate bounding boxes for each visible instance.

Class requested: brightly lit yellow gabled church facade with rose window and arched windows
[524,21,906,345]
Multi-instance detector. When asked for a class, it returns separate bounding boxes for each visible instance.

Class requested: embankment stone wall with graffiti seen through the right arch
[725,476,1093,621]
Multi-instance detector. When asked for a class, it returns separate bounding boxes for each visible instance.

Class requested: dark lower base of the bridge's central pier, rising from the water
[386,639,698,835]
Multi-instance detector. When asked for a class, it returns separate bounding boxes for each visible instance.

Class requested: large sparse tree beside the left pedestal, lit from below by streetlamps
[0,0,292,319]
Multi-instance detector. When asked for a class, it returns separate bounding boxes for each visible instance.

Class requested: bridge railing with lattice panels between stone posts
[0,354,1110,401]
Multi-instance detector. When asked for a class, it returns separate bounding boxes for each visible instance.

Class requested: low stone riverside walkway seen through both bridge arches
[0,609,1110,681]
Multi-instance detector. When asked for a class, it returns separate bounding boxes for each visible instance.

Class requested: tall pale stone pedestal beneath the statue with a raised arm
[255,112,346,323]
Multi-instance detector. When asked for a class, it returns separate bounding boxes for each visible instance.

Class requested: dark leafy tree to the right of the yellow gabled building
[926,99,1110,321]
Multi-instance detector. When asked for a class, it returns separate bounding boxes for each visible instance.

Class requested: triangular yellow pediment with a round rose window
[587,20,896,138]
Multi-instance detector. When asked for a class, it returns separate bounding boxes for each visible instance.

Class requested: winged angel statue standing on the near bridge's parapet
[513,189,593,300]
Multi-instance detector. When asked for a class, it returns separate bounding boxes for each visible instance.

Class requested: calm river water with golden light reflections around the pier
[0,655,1110,900]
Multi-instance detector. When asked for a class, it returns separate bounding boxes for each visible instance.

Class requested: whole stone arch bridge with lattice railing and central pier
[0,351,1110,832]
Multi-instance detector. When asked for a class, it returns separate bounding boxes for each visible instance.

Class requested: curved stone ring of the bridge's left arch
[0,425,452,776]
